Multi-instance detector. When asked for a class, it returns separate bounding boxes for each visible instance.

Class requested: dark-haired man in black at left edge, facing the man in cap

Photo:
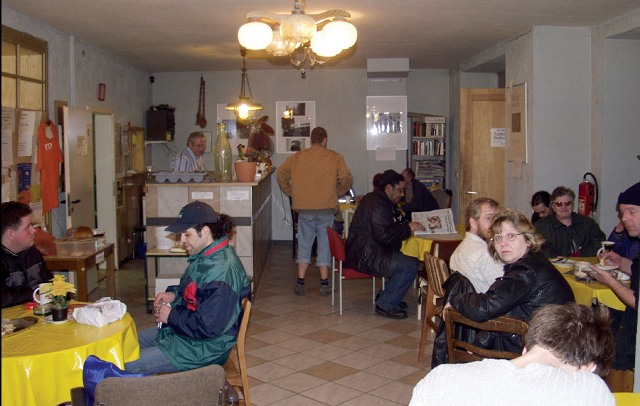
[1,202,53,308]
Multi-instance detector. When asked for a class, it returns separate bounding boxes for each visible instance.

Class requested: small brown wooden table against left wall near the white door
[44,244,116,302]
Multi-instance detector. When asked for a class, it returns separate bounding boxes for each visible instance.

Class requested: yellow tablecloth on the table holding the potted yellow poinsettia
[2,305,140,406]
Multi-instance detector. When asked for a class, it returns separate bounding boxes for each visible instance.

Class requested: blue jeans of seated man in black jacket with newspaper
[376,252,420,311]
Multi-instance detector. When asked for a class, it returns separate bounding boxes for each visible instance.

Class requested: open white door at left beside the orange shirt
[63,107,96,228]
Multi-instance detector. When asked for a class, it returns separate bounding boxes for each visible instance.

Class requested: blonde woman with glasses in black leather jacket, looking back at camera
[447,209,575,351]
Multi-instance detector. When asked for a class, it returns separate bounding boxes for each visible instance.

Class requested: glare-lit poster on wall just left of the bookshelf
[365,96,407,151]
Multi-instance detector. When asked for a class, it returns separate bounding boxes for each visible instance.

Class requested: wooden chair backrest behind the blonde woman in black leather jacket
[444,308,529,364]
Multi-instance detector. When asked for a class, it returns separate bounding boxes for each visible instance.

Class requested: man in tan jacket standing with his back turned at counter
[278,127,353,296]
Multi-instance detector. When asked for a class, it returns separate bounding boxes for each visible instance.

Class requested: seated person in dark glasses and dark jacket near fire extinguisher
[536,186,607,258]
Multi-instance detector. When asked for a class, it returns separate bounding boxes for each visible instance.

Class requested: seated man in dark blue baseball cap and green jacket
[125,201,251,374]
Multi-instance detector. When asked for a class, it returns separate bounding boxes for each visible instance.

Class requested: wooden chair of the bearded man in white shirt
[418,254,449,361]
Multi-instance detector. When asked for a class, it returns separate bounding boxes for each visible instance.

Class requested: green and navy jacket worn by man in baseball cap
[156,238,251,370]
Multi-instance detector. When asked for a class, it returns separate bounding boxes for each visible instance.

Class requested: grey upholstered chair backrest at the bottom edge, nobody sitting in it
[95,365,225,406]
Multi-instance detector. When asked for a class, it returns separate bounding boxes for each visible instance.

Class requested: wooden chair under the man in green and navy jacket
[225,299,251,406]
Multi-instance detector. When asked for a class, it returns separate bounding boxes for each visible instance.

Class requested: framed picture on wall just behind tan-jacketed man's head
[276,101,316,154]
